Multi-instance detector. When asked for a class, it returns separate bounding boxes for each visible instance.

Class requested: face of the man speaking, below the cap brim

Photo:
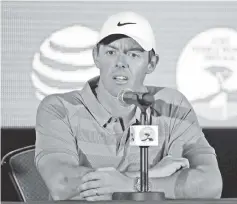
[93,37,153,97]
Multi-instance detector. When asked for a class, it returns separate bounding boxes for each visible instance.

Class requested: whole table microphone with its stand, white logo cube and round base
[112,89,165,201]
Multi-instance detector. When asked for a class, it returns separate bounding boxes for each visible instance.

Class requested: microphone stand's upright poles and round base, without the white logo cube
[112,104,165,201]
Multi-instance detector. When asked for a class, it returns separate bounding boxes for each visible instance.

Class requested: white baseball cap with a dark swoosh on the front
[98,11,156,53]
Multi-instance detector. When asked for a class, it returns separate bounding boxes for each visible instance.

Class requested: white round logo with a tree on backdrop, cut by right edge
[176,28,237,120]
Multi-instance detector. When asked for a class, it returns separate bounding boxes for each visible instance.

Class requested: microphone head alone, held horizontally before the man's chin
[117,89,155,106]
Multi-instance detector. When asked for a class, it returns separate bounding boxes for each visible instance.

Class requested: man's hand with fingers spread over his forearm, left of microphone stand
[79,168,133,201]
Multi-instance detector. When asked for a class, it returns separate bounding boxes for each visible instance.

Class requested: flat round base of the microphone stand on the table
[112,192,165,201]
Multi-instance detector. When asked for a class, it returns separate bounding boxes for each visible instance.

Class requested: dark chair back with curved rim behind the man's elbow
[2,145,49,202]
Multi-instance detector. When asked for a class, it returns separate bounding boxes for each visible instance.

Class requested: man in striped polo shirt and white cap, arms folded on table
[35,12,222,201]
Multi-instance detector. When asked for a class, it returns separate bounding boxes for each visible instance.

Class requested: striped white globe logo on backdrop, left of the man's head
[31,25,99,100]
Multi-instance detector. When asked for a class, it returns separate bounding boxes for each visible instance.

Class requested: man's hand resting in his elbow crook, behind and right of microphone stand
[125,155,189,178]
